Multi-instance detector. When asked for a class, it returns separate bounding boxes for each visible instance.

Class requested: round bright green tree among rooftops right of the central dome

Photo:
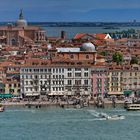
[112,52,123,65]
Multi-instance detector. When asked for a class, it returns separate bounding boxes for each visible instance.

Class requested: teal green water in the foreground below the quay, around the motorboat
[0,107,140,140]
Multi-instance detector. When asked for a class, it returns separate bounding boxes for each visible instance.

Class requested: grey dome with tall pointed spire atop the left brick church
[16,9,27,28]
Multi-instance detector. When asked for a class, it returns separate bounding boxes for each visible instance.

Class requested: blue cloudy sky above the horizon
[0,0,140,22]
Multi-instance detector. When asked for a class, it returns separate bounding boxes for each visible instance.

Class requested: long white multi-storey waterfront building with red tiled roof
[20,58,91,97]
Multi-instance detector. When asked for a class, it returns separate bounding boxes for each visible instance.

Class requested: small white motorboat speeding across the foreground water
[99,113,125,120]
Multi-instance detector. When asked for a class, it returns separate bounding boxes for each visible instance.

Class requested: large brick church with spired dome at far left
[0,10,46,46]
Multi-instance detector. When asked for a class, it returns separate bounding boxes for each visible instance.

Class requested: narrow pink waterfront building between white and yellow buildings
[91,66,108,97]
